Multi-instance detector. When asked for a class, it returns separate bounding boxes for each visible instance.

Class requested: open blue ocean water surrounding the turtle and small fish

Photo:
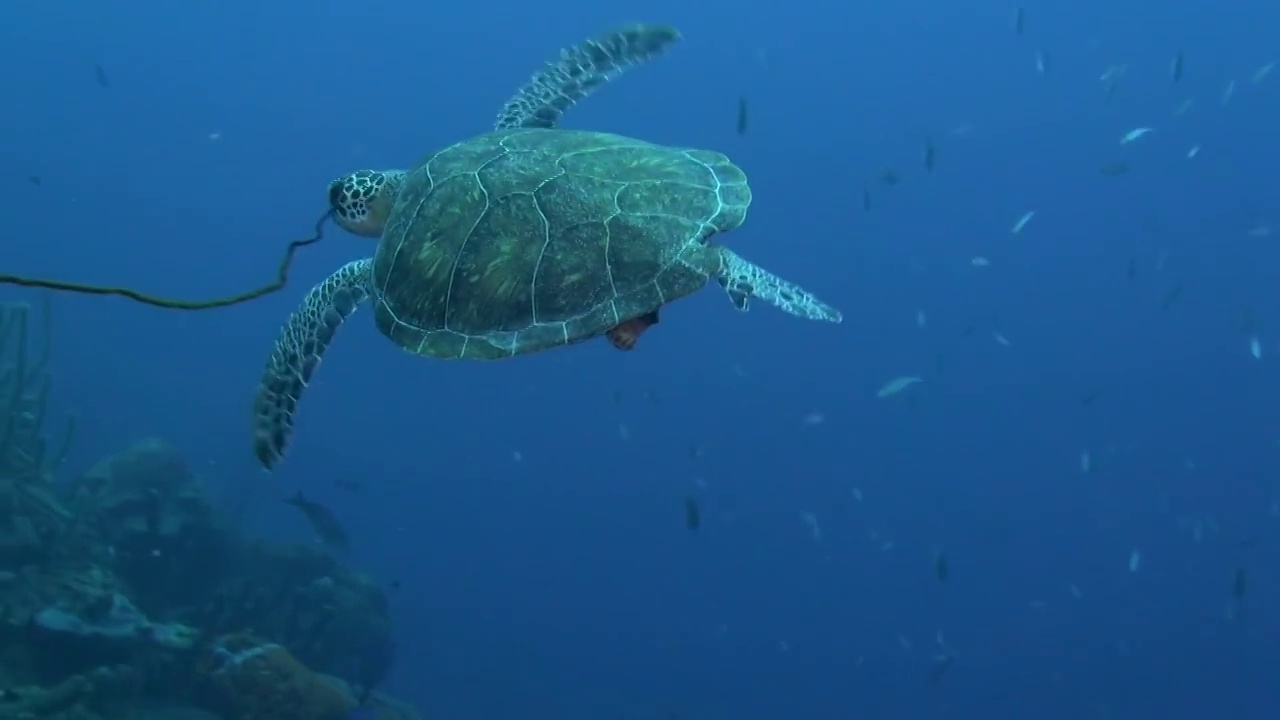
[0,0,1280,720]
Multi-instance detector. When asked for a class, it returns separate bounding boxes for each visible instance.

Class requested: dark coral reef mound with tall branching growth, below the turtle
[0,305,416,720]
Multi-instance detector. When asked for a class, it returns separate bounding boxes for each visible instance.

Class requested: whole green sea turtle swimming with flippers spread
[253,26,841,469]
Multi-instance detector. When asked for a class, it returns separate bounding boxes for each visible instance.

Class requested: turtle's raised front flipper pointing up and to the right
[494,24,680,131]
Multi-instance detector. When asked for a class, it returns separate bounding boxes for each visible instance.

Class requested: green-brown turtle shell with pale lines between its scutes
[372,129,751,359]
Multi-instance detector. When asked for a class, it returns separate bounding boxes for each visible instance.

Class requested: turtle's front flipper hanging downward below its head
[253,259,374,470]
